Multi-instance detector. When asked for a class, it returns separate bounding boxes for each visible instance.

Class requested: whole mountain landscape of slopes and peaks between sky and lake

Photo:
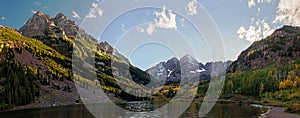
[0,11,300,117]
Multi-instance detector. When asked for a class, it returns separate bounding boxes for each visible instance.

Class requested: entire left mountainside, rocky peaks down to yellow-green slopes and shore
[0,11,158,110]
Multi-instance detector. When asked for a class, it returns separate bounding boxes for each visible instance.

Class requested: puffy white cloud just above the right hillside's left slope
[237,20,274,42]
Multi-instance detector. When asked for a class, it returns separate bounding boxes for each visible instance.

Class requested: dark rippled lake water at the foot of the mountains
[0,102,267,118]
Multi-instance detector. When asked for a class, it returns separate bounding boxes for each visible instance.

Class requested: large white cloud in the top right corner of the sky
[273,0,300,26]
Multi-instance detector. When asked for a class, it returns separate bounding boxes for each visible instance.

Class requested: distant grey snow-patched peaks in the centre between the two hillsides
[146,55,231,84]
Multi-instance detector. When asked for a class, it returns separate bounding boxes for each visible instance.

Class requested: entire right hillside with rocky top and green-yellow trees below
[224,26,300,112]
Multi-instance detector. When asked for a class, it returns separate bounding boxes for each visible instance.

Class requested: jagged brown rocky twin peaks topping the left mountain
[19,11,96,57]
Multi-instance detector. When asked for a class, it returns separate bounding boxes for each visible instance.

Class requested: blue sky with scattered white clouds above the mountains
[0,0,300,69]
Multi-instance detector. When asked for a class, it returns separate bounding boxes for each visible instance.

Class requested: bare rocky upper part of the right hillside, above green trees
[228,26,300,72]
